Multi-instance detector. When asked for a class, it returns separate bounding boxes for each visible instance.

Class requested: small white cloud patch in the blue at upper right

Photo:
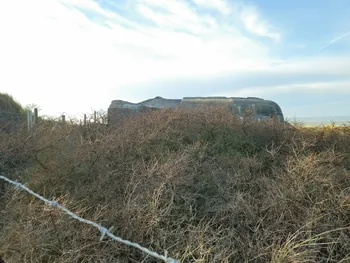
[241,5,281,41]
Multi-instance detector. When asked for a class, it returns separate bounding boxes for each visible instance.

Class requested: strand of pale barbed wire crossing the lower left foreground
[0,175,180,263]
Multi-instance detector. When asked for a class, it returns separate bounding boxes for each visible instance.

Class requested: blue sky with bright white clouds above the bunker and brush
[0,0,350,117]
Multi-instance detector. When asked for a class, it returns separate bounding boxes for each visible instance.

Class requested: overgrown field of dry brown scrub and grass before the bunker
[0,109,350,263]
